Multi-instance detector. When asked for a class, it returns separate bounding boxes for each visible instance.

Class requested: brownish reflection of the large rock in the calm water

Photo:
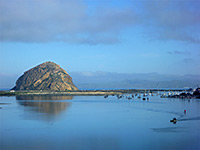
[16,95,73,117]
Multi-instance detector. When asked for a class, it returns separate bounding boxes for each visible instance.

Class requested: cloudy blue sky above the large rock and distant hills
[0,0,200,86]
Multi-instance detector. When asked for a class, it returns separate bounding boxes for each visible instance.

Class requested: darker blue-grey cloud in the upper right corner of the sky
[143,0,200,44]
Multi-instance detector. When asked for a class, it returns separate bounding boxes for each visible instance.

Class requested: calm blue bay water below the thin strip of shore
[0,96,200,150]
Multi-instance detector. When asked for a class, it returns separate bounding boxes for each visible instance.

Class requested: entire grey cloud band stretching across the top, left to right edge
[0,0,200,44]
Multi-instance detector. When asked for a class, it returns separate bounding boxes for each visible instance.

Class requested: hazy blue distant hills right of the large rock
[70,71,200,89]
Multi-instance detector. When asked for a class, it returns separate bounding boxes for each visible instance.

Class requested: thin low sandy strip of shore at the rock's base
[0,89,186,96]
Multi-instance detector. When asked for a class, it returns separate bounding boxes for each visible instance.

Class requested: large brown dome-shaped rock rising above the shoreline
[13,61,78,91]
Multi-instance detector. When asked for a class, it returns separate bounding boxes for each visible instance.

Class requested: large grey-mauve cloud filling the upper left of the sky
[0,0,136,44]
